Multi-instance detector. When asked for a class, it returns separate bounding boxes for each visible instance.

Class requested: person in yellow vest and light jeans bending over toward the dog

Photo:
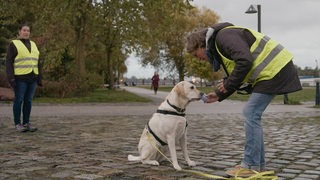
[186,22,302,177]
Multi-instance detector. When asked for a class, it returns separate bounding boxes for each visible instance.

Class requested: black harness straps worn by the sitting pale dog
[146,100,188,146]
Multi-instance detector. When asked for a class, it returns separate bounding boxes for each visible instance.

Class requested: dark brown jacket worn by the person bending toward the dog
[209,23,302,101]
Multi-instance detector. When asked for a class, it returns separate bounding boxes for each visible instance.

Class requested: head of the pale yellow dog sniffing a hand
[172,81,201,103]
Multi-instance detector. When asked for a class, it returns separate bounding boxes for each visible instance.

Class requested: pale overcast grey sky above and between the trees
[125,0,320,78]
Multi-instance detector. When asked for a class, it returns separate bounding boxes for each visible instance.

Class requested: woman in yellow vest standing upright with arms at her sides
[6,24,42,132]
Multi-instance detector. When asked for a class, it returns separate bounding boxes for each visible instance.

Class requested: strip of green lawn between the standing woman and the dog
[33,89,151,104]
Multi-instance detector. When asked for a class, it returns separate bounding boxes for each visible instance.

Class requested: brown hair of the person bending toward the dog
[186,28,208,53]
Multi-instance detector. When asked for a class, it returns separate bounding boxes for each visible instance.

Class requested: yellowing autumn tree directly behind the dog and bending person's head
[138,0,219,81]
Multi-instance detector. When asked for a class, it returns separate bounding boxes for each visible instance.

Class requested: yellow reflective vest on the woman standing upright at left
[12,40,39,75]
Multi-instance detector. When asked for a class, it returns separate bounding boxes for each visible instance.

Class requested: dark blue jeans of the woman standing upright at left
[13,81,37,125]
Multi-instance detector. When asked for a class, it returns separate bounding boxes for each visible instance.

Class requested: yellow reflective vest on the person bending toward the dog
[215,26,293,85]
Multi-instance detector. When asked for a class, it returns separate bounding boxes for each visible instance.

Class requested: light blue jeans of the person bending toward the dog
[241,93,275,171]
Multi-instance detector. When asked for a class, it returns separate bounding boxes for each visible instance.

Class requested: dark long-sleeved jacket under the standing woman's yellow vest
[6,39,42,85]
